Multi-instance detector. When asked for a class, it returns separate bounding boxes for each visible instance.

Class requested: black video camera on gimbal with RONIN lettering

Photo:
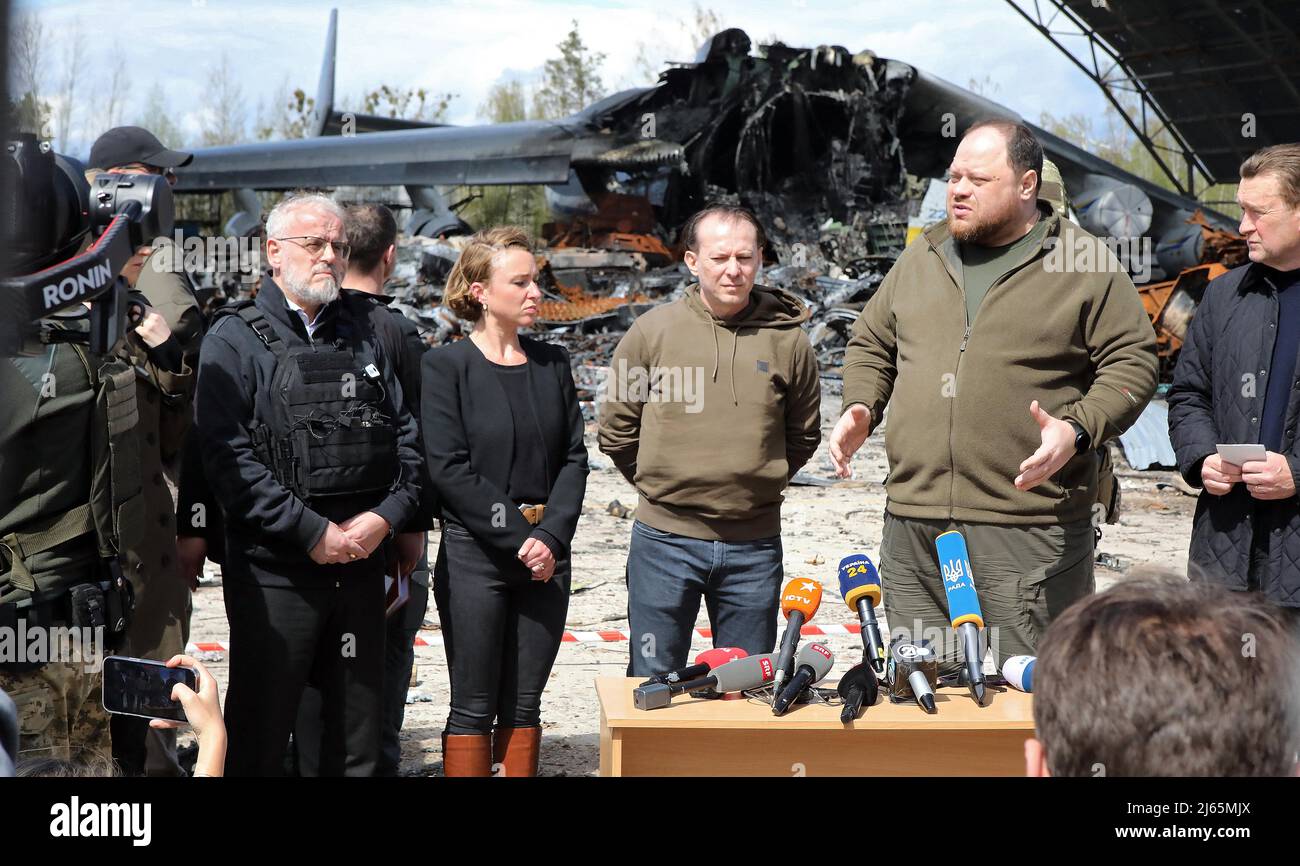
[0,133,174,356]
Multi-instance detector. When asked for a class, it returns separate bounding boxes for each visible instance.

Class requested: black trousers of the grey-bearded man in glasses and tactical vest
[225,559,384,776]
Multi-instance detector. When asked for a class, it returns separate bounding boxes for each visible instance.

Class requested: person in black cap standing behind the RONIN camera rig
[90,126,203,776]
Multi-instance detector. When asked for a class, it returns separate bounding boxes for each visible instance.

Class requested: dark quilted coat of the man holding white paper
[1169,264,1300,607]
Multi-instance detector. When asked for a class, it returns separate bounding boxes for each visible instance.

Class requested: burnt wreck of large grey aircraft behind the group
[177,12,1235,378]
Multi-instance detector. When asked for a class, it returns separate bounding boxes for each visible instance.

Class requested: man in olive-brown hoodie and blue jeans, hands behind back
[599,205,822,676]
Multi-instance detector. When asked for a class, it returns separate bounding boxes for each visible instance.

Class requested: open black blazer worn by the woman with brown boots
[420,337,588,555]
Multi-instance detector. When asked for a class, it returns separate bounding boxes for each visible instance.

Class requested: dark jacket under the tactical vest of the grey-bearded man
[195,278,420,585]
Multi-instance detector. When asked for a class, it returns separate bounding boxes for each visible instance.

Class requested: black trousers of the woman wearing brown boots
[433,521,569,733]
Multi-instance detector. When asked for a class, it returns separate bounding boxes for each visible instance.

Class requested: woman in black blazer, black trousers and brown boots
[421,226,588,776]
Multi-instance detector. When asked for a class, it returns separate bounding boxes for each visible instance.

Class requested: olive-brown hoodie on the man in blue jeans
[601,278,820,541]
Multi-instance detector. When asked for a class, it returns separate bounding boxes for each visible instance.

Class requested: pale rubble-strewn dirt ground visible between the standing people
[191,394,1196,776]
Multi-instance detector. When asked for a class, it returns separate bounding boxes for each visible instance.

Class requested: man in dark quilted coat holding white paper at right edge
[1169,144,1300,607]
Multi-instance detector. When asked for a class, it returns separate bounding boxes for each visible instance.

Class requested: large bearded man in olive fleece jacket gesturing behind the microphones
[829,121,1157,674]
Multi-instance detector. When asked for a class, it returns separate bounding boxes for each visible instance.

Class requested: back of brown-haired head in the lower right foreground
[1024,575,1300,776]
